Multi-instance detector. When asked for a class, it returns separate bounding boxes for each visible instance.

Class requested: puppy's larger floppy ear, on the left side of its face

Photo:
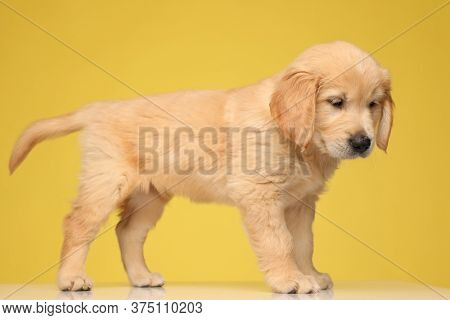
[270,71,319,151]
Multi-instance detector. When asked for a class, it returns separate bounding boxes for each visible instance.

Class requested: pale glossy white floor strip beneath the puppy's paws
[0,282,450,300]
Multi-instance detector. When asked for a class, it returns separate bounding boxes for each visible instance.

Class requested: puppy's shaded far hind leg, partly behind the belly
[116,188,169,287]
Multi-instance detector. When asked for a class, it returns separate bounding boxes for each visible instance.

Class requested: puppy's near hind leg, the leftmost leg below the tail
[58,159,135,291]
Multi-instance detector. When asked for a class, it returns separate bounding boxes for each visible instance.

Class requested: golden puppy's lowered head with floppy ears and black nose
[270,42,393,159]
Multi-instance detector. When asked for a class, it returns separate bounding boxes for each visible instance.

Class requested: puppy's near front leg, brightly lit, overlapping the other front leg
[244,201,320,293]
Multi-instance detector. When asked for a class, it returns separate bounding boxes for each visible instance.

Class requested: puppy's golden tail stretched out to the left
[9,108,89,174]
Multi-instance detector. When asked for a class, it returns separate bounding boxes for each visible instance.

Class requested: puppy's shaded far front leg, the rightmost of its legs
[285,196,333,289]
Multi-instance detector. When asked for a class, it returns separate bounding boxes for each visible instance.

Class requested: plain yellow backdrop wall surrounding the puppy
[0,0,450,287]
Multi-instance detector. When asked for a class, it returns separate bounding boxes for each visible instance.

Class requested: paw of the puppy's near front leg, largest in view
[268,275,320,293]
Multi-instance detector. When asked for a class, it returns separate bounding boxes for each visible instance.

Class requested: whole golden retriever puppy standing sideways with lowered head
[9,42,393,293]
